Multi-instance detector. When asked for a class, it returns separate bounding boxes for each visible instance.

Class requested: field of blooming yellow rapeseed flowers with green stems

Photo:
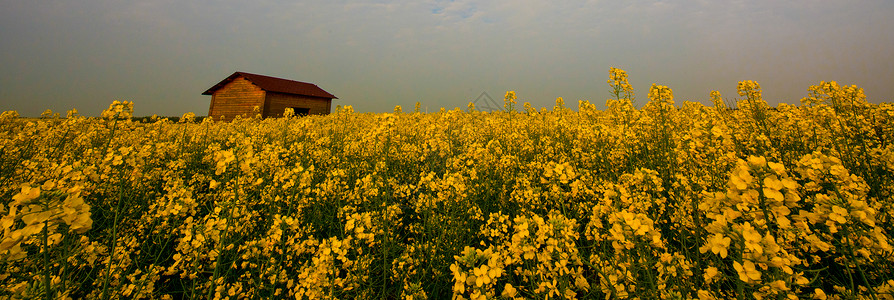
[0,69,894,299]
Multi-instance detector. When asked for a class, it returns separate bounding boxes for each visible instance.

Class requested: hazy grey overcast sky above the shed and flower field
[0,0,894,116]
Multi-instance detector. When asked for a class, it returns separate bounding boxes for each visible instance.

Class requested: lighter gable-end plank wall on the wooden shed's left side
[208,76,266,121]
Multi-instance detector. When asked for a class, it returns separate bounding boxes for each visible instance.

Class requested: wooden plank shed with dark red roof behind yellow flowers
[202,72,338,121]
